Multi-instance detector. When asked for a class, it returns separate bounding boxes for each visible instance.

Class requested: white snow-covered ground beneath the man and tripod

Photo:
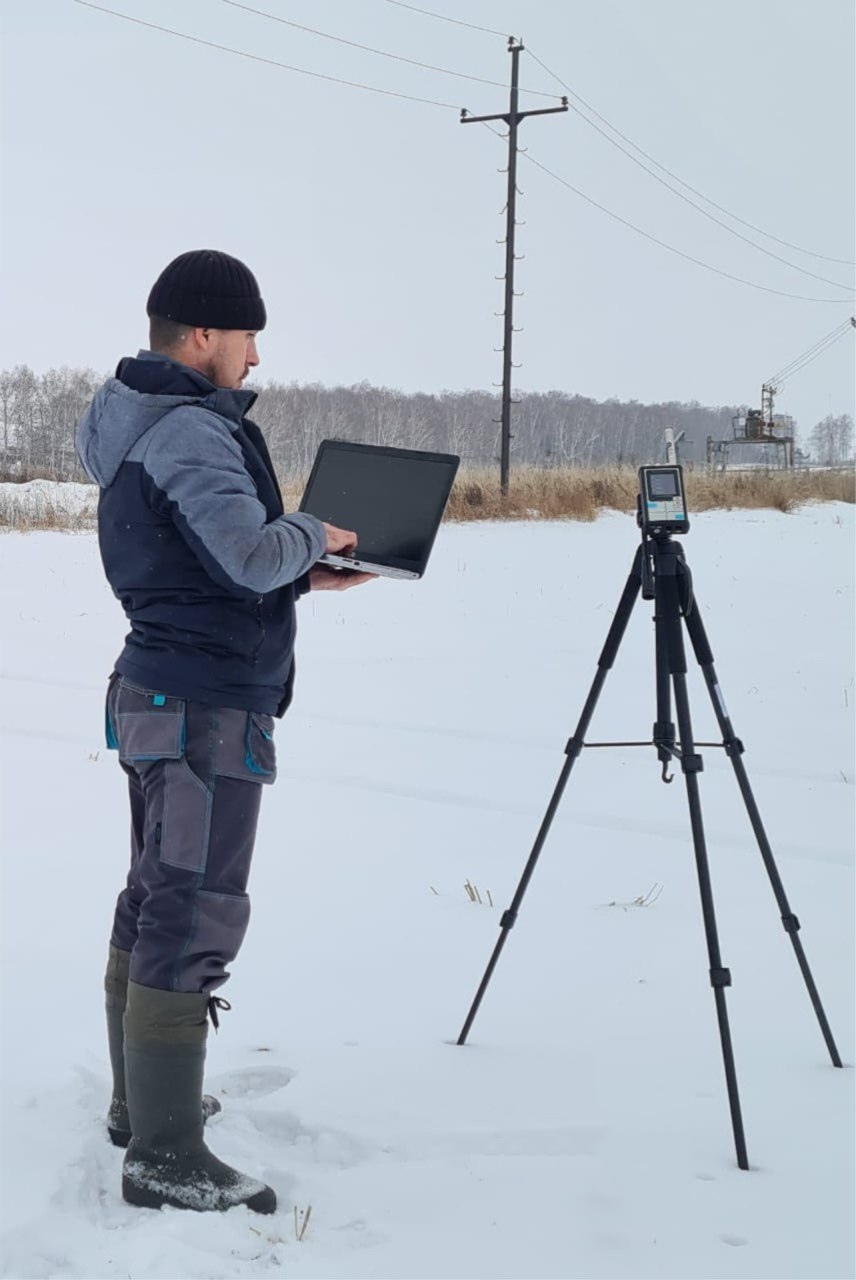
[0,506,856,1280]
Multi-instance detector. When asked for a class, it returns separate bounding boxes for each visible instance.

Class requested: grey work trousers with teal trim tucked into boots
[106,672,276,992]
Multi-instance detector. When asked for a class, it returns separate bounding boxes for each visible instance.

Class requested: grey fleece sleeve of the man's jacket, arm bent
[142,408,326,595]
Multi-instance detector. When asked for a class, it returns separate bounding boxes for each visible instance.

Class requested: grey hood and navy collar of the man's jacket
[77,351,256,489]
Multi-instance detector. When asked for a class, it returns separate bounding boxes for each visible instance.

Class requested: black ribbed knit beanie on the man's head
[146,248,267,329]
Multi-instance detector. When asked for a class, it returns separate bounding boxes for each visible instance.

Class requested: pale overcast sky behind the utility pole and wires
[0,0,856,433]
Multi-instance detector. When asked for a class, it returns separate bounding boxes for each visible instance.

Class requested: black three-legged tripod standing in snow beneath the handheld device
[458,530,842,1169]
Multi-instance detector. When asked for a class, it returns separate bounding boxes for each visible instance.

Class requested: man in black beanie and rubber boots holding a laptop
[77,250,371,1213]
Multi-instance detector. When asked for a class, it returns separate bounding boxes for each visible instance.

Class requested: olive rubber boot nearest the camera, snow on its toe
[122,982,276,1213]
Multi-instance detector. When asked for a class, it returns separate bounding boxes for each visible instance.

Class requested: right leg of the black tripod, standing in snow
[686,570,842,1066]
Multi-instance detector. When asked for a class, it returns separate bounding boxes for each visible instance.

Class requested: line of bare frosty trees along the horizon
[0,365,853,480]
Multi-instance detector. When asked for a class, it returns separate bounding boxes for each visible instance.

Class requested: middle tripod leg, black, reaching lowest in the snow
[654,543,749,1169]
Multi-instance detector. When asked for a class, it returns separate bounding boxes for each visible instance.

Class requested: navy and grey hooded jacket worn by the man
[77,351,326,716]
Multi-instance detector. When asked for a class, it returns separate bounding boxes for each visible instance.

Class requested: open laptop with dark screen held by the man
[299,440,461,579]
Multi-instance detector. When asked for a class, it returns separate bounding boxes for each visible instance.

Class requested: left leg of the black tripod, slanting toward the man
[458,547,642,1044]
